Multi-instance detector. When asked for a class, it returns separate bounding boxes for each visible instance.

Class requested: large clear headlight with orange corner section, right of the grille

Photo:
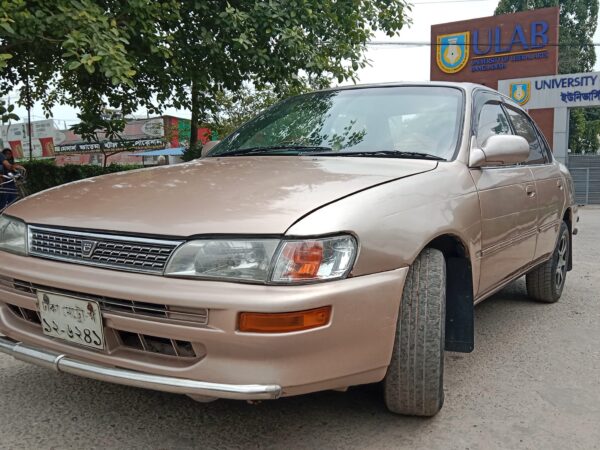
[165,236,357,284]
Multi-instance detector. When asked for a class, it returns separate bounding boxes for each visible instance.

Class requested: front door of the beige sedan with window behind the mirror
[471,91,537,295]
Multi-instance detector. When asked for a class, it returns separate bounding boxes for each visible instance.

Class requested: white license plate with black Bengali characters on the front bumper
[37,291,104,349]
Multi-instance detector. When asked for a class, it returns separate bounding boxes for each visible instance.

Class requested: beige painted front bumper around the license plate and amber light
[0,252,408,399]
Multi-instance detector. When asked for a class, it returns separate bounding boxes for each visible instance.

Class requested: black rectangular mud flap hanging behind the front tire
[445,258,475,353]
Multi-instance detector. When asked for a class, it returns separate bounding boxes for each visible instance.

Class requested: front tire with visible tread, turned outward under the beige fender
[383,248,446,416]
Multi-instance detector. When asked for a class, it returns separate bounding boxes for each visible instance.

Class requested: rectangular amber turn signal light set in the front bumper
[239,306,331,333]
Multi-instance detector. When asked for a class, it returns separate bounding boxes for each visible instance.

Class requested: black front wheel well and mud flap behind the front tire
[425,233,475,353]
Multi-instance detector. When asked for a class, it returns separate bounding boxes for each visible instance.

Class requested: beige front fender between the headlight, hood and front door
[286,161,481,284]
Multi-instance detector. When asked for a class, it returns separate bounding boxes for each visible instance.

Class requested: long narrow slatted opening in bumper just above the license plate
[0,276,208,325]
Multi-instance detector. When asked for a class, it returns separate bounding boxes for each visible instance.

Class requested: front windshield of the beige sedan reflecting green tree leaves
[209,86,463,160]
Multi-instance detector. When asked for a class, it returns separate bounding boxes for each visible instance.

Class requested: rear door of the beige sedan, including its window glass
[506,105,565,259]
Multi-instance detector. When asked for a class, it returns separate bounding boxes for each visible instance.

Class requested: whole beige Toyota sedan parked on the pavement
[0,83,577,416]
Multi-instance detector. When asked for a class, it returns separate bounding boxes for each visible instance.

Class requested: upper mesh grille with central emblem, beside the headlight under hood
[29,226,181,273]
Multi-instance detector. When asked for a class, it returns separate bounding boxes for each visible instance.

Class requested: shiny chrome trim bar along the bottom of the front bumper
[0,336,281,400]
